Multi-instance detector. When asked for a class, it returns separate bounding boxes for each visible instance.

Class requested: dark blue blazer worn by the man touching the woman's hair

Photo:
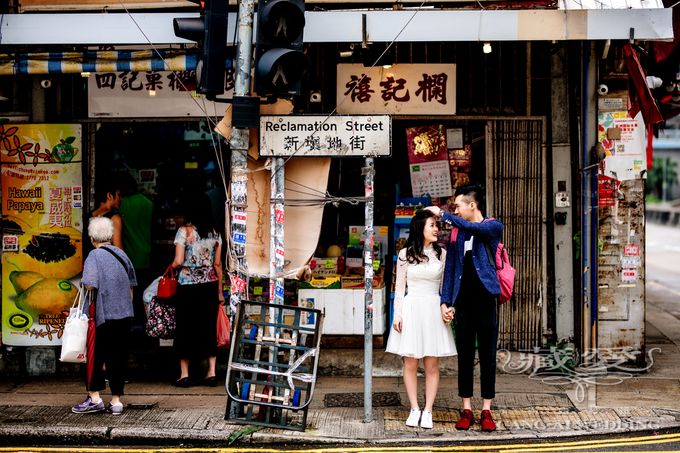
[441,212,503,306]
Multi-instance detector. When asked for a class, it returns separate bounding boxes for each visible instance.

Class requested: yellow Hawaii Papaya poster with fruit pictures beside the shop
[0,124,83,346]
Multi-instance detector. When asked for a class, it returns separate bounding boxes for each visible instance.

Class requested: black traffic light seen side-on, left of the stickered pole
[172,0,228,99]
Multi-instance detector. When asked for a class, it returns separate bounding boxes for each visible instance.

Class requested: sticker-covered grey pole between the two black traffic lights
[224,0,255,306]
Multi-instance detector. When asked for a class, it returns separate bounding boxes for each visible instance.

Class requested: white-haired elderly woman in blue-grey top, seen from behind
[71,217,137,415]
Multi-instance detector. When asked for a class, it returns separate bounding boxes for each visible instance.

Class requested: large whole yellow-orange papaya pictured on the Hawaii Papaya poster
[16,278,78,318]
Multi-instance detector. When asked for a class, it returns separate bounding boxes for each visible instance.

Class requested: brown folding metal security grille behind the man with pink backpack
[486,118,546,350]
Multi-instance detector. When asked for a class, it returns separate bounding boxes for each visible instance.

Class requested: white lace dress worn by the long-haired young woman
[386,246,457,359]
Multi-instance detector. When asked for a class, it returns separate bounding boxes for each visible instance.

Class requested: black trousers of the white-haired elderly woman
[86,318,132,395]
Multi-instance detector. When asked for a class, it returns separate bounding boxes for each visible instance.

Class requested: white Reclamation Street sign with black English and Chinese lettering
[260,115,392,157]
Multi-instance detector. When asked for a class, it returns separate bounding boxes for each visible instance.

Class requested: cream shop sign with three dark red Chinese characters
[336,64,456,115]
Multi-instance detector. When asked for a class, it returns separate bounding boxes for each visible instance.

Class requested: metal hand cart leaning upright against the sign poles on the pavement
[224,301,323,431]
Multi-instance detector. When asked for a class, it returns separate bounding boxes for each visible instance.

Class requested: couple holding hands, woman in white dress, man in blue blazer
[387,186,503,431]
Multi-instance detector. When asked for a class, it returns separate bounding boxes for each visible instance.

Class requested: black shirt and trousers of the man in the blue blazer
[455,254,498,399]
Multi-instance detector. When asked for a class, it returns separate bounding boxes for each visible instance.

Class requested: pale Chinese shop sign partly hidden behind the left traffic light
[87,70,234,118]
